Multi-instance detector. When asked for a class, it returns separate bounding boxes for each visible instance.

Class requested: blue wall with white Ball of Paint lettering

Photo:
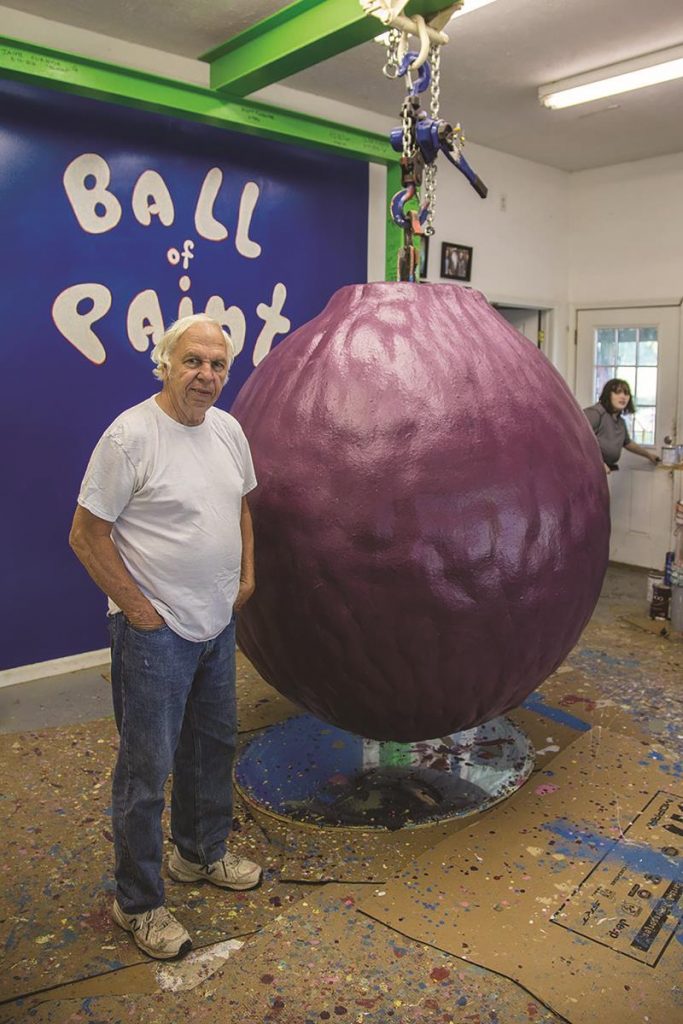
[0,83,368,669]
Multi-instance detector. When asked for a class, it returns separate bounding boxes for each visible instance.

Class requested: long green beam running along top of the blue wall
[0,36,396,164]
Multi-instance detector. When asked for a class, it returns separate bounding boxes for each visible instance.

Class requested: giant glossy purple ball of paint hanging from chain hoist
[232,284,609,741]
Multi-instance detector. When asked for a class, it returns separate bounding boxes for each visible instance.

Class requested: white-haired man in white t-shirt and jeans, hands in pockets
[70,314,261,959]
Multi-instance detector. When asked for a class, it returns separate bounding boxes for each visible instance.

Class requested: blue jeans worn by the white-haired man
[110,612,237,913]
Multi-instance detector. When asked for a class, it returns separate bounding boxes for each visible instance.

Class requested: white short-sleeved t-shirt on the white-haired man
[78,396,256,641]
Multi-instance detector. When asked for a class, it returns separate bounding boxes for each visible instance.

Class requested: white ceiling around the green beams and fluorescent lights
[0,0,683,171]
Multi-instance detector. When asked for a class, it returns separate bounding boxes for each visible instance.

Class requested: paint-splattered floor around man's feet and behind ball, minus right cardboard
[0,566,683,1024]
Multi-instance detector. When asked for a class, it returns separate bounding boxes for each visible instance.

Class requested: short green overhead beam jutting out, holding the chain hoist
[202,0,455,96]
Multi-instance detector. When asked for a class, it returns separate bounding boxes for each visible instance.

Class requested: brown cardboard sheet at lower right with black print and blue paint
[359,727,683,1024]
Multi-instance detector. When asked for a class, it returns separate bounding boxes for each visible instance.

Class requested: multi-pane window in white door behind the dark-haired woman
[593,327,658,444]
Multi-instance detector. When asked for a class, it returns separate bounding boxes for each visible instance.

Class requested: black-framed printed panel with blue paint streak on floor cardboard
[550,791,683,967]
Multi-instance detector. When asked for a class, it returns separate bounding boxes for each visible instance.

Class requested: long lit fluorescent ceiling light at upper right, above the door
[539,46,683,111]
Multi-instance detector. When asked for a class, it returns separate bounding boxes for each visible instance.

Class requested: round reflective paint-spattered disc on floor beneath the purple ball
[234,715,535,830]
